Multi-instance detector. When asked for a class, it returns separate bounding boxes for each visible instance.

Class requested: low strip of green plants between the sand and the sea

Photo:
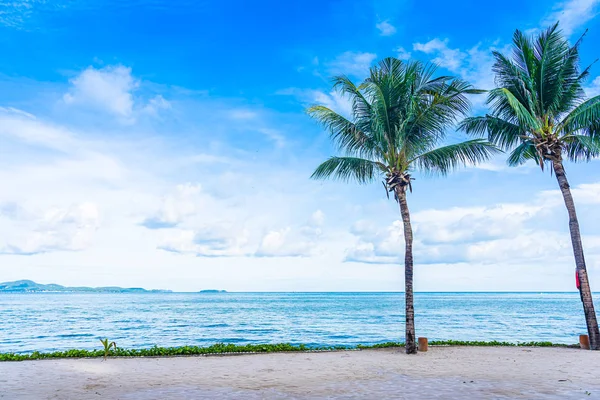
[0,340,579,361]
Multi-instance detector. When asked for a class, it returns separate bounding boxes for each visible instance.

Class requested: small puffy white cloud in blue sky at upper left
[63,65,139,118]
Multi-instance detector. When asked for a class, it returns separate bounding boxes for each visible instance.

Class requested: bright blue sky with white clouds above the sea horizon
[0,0,600,291]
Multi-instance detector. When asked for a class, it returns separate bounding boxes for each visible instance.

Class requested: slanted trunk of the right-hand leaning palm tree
[552,160,600,350]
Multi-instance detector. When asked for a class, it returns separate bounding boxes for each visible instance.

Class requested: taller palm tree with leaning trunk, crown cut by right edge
[461,23,600,350]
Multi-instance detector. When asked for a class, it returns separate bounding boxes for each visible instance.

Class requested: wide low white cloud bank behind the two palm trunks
[345,184,600,265]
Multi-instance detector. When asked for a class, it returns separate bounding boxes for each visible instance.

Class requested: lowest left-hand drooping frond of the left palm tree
[311,157,385,184]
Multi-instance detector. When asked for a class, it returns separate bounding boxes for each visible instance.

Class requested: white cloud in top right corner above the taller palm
[542,0,600,35]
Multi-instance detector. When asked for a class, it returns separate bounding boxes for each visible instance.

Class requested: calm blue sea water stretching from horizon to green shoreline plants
[0,293,598,352]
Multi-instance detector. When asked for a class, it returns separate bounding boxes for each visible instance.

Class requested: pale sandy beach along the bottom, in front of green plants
[0,347,600,400]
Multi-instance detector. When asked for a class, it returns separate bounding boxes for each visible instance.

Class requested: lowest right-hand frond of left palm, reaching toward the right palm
[411,139,501,175]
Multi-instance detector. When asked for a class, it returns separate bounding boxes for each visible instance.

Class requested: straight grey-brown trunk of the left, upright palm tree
[396,187,417,354]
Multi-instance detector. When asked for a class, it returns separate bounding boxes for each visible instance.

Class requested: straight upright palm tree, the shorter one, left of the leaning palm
[307,58,497,354]
